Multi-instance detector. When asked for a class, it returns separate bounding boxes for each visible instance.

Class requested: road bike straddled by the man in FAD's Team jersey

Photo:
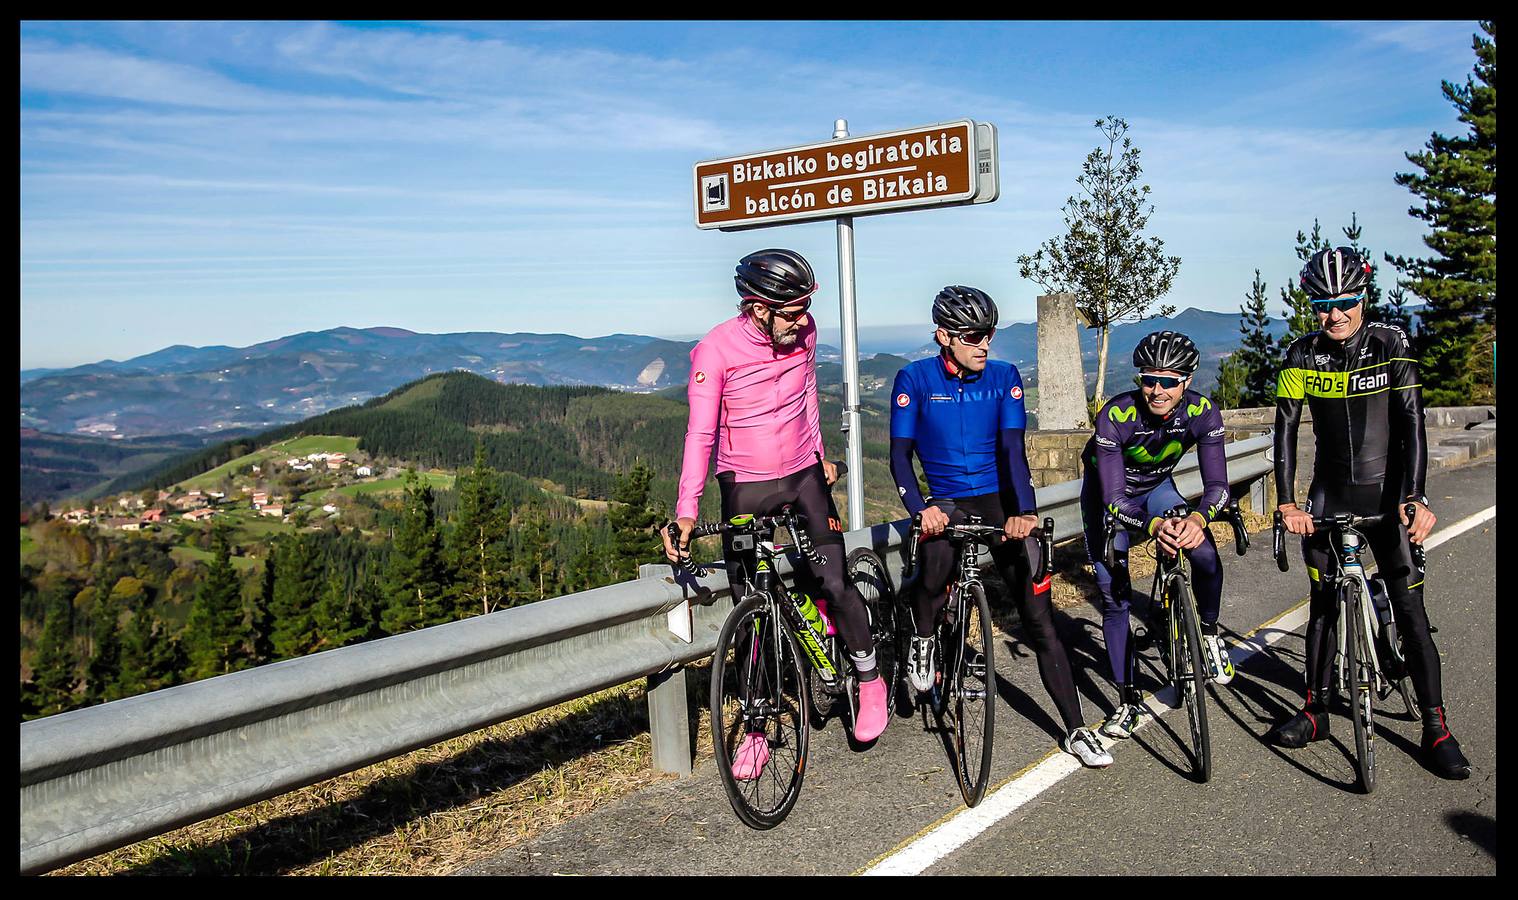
[1271,504,1424,794]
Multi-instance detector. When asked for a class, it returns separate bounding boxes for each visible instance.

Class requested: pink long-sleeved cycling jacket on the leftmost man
[674,313,824,519]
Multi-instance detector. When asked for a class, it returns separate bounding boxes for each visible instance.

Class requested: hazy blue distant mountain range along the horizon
[20,310,1402,440]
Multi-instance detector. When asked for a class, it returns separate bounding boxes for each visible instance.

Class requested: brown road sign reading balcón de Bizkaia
[695,118,997,229]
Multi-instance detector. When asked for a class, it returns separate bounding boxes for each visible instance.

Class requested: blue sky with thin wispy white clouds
[20,21,1477,369]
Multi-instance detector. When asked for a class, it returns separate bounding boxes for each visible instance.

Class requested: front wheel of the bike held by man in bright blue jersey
[944,584,996,806]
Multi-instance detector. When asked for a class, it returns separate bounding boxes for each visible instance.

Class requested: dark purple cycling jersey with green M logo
[1082,390,1228,530]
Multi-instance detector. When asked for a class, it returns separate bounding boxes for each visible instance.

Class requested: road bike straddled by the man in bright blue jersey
[897,515,1053,806]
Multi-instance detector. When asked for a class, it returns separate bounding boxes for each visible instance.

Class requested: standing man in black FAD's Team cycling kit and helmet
[1266,247,1471,779]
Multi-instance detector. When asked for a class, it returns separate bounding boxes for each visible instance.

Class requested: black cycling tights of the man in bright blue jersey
[903,493,1085,732]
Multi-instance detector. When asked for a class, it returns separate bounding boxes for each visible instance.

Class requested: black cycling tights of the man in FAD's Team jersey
[1302,481,1444,709]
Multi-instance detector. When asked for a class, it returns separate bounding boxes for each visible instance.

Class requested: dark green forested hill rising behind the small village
[115,370,900,521]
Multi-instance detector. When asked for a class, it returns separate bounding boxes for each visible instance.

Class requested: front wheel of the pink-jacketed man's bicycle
[710,595,811,829]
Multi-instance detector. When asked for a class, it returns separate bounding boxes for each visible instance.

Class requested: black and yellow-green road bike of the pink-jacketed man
[669,505,896,830]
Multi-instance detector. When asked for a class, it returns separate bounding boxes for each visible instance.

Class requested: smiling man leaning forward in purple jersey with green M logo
[1081,331,1234,738]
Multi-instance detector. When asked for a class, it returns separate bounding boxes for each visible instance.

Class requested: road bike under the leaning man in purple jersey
[1102,499,1249,783]
